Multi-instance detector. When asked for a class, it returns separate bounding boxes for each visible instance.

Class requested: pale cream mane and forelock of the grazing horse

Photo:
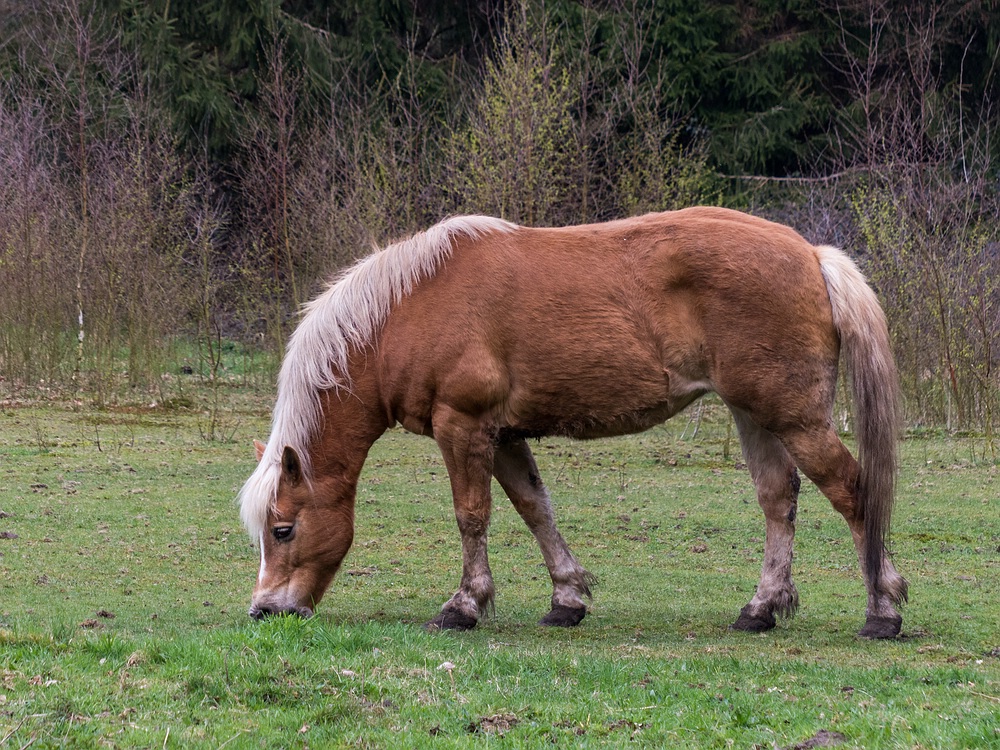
[239,216,517,542]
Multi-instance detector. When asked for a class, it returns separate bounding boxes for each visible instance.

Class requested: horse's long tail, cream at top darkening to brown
[817,247,905,596]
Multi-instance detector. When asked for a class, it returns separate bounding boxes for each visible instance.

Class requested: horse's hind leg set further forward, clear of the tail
[730,409,799,633]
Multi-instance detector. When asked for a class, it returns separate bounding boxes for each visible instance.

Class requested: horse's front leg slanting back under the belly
[493,439,594,627]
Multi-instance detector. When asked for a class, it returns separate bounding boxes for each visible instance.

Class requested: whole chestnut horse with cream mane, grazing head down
[241,208,907,638]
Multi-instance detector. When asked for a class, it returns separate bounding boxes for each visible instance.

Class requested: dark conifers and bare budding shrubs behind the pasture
[0,0,1000,435]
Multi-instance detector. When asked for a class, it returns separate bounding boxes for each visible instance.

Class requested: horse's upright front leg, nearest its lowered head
[426,407,495,630]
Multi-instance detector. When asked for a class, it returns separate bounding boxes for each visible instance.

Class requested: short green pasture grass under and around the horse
[0,388,1000,748]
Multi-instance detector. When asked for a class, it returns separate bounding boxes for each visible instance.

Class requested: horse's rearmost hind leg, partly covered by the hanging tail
[782,425,907,638]
